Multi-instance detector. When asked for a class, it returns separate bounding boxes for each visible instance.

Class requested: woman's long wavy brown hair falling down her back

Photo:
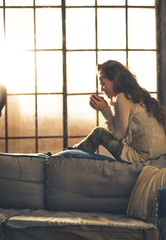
[98,60,166,128]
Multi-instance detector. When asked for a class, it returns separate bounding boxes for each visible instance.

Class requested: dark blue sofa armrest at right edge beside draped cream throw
[157,186,166,219]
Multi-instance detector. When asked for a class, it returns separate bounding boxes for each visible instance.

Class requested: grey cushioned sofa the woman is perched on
[0,150,166,240]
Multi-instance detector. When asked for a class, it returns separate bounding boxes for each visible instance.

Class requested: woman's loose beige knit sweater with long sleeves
[102,93,166,163]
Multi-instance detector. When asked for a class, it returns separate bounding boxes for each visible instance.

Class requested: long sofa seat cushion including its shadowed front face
[5,210,159,240]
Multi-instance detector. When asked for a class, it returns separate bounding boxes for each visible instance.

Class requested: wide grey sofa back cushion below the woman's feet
[46,150,130,213]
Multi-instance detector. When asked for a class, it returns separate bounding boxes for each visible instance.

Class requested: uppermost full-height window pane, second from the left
[36,8,62,49]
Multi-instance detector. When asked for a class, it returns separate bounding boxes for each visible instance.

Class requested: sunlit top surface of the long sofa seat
[7,209,158,230]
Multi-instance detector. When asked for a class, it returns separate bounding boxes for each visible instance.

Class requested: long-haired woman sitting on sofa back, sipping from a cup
[74,60,166,163]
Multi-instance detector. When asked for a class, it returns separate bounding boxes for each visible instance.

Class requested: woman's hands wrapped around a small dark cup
[89,95,108,111]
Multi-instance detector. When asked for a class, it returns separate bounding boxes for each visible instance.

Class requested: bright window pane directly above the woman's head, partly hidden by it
[98,51,126,65]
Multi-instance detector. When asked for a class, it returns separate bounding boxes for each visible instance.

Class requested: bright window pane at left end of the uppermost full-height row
[6,9,34,49]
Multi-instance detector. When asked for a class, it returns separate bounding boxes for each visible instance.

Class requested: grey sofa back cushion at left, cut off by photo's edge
[0,154,46,209]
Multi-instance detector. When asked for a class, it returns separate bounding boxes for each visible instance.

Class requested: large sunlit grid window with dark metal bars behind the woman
[0,0,157,153]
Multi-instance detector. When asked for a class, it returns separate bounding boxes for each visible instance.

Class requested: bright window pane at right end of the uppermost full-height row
[128,9,156,49]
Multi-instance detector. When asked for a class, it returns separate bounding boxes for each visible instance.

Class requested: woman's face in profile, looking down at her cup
[99,74,116,98]
